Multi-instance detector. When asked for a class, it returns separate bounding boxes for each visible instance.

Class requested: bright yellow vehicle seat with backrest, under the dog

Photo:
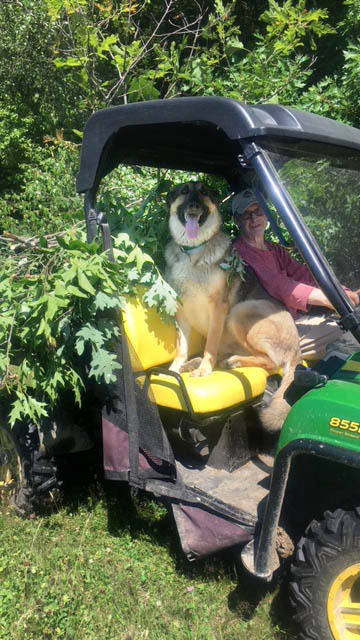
[123,296,279,414]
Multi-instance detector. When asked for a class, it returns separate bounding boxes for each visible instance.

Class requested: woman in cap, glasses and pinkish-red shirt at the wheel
[232,189,360,360]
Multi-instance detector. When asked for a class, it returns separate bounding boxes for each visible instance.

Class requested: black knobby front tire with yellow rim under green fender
[290,508,360,640]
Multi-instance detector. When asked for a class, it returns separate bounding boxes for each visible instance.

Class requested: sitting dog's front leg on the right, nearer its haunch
[190,298,228,377]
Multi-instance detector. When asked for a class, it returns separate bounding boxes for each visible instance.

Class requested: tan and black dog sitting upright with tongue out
[165,182,302,432]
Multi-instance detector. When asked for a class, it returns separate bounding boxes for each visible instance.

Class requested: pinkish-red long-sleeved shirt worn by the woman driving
[233,237,317,316]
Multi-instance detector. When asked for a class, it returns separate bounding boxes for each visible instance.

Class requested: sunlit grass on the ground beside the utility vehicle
[0,485,296,640]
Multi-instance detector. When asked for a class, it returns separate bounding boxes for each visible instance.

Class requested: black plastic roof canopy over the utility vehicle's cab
[77,97,360,192]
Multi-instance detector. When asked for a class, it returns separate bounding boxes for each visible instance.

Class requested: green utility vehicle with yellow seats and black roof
[0,97,360,640]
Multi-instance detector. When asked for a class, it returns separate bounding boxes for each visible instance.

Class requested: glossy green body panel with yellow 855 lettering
[278,353,360,454]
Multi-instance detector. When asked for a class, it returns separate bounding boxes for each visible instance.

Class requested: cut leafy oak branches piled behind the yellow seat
[0,230,175,424]
